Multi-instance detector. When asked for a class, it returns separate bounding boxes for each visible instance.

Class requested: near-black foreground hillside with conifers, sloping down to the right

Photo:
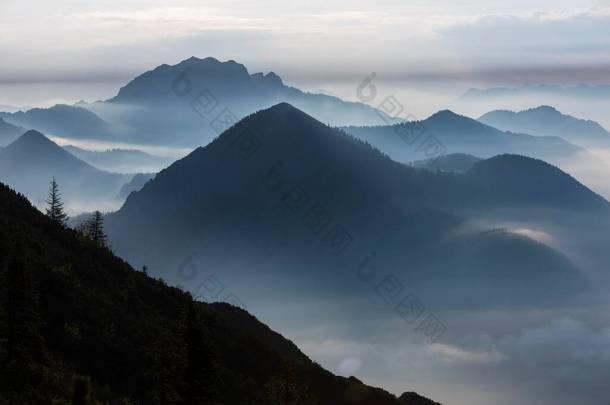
[0,184,434,405]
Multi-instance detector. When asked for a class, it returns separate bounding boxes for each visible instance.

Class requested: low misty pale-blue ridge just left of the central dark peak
[64,145,176,173]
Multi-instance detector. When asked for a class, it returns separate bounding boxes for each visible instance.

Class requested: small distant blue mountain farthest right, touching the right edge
[478,106,610,147]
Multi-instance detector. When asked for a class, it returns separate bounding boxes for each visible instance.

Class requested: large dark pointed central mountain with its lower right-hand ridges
[107,103,592,305]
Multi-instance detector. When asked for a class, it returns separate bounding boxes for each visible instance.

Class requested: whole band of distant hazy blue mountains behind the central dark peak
[0,57,605,172]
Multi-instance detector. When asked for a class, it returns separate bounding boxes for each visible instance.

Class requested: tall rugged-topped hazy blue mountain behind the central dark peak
[76,57,393,147]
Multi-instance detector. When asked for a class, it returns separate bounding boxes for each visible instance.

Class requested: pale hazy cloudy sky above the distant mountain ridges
[0,0,610,104]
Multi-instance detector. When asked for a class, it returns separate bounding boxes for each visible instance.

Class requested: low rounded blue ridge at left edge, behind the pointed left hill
[0,104,116,141]
